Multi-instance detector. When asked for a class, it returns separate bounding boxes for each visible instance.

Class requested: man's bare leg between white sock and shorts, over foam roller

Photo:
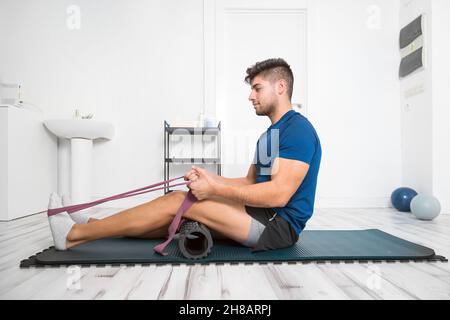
[67,191,251,248]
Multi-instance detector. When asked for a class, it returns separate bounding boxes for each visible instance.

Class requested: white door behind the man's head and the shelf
[204,0,308,177]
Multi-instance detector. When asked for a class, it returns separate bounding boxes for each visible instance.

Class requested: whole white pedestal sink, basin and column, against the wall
[44,119,114,204]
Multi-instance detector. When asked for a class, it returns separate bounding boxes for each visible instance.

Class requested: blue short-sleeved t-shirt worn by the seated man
[253,110,322,234]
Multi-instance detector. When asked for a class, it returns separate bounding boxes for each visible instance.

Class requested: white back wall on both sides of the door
[0,0,401,207]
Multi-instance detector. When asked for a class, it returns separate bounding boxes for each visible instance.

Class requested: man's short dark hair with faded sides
[245,58,294,100]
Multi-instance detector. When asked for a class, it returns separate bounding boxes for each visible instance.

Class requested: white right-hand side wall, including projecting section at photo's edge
[400,0,450,214]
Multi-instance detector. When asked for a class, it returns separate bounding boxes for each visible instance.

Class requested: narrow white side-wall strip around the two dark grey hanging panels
[397,0,433,198]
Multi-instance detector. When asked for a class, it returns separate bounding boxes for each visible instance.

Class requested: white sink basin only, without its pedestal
[44,119,114,140]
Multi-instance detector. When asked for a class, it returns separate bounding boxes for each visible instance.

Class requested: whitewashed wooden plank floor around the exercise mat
[0,209,450,300]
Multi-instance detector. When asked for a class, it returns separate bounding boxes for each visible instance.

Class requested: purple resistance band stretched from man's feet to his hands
[47,176,197,256]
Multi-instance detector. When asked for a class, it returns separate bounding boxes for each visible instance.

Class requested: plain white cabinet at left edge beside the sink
[0,106,57,221]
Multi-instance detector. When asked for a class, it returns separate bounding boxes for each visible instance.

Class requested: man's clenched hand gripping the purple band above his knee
[184,166,217,201]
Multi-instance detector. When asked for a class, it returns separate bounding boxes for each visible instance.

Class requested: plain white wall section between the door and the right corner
[309,0,401,207]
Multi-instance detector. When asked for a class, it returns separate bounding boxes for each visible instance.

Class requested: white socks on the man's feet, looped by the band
[48,192,75,250]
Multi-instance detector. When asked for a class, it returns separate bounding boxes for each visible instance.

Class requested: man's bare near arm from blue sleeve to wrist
[216,158,309,208]
